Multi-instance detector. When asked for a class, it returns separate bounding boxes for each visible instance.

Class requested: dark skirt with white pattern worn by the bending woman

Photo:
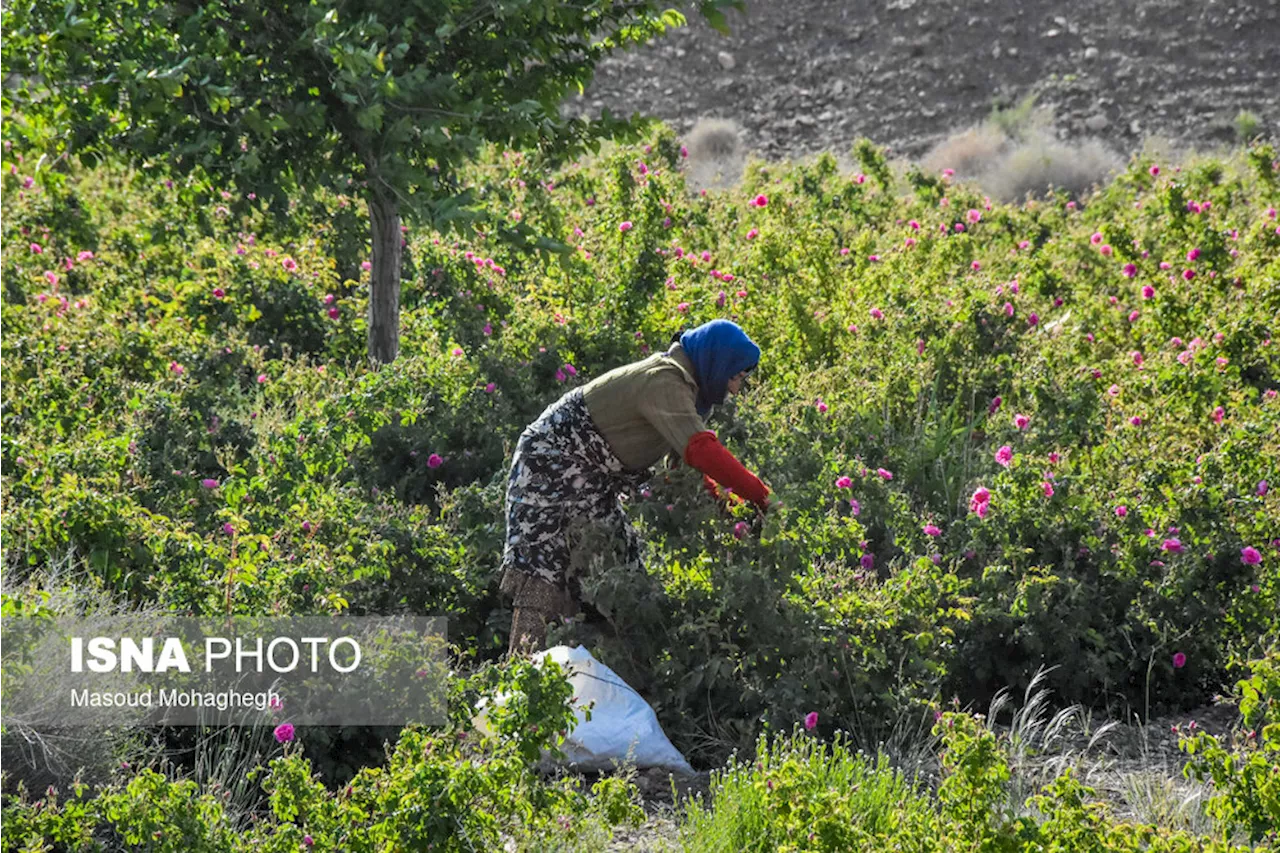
[502,388,649,601]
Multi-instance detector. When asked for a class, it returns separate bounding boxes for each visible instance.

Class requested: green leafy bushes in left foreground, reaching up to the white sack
[0,661,643,853]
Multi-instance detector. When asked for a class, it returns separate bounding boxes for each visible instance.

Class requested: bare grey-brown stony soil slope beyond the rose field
[566,0,1280,160]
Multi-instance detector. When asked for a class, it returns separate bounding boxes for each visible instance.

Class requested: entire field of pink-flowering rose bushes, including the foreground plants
[0,129,1280,850]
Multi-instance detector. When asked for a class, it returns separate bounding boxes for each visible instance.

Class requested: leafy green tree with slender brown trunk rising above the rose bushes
[0,0,742,360]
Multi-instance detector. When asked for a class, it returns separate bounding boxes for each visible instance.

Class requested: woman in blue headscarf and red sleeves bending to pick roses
[502,320,769,652]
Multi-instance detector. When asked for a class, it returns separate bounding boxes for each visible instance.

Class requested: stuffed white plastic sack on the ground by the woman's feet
[472,646,694,774]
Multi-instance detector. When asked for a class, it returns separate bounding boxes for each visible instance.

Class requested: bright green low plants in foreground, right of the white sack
[682,712,1270,853]
